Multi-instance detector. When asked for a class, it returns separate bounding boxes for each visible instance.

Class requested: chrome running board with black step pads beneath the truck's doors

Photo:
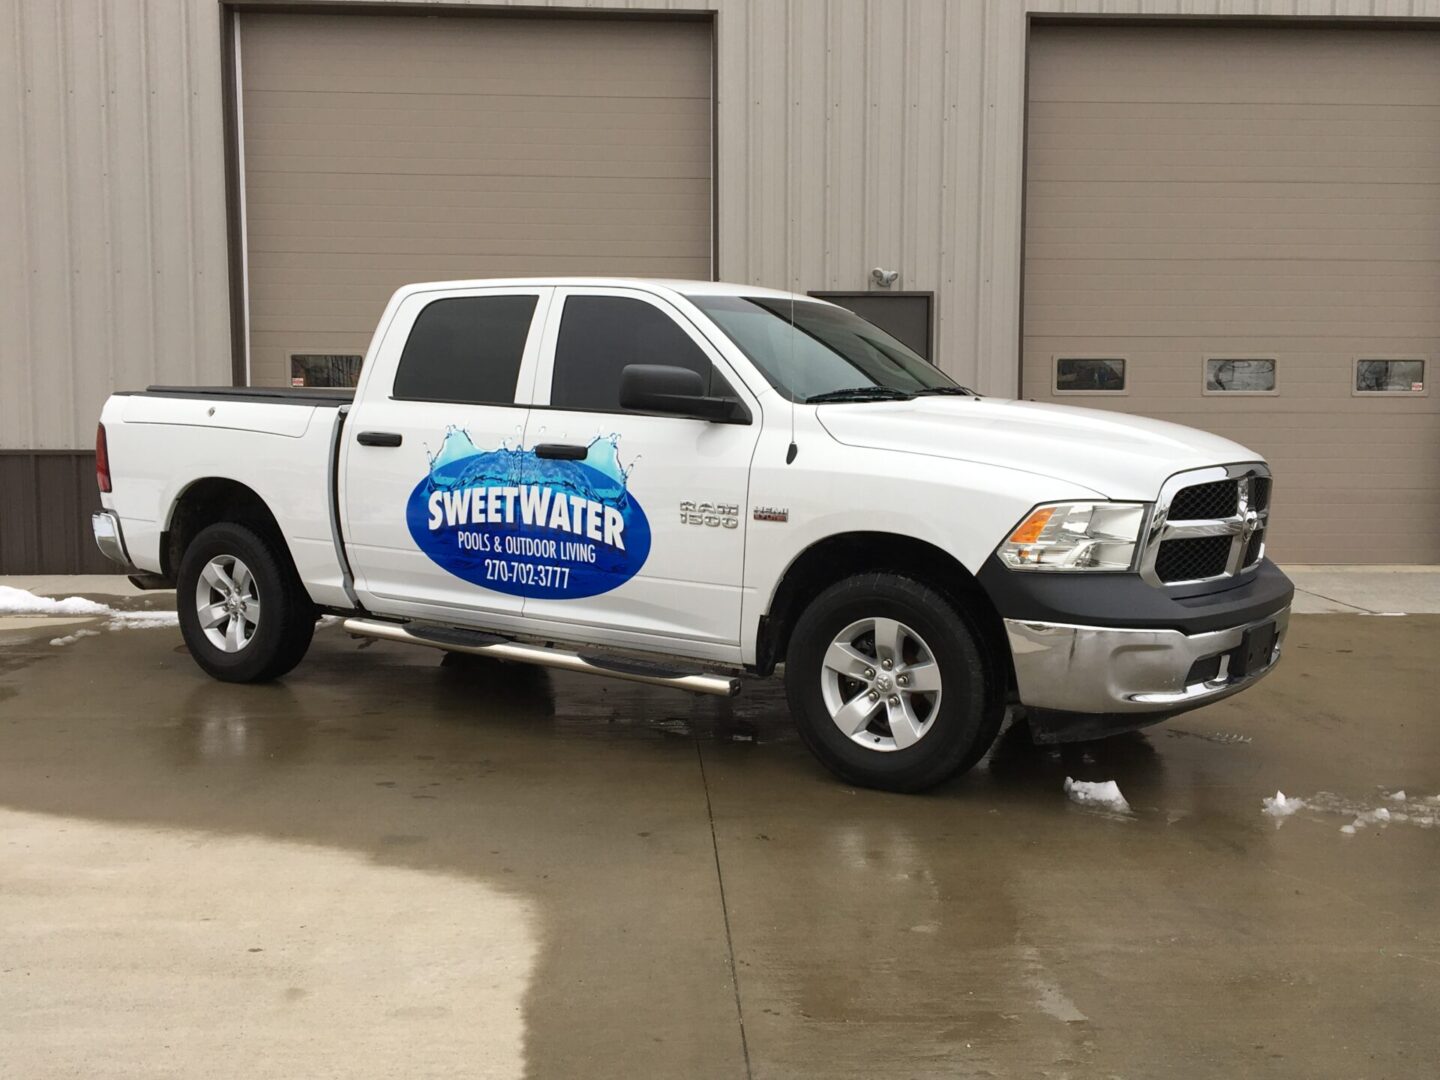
[344,619,740,697]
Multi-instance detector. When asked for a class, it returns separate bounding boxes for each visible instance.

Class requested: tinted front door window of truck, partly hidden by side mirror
[550,297,714,412]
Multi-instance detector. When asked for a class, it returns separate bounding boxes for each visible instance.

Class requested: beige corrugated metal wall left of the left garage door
[0,0,229,448]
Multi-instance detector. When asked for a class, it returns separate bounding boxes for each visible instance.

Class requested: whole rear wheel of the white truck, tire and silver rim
[176,521,315,683]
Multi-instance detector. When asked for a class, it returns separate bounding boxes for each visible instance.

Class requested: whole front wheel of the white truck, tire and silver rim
[785,573,1002,792]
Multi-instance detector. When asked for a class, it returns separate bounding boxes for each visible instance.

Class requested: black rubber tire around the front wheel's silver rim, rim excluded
[785,573,1004,792]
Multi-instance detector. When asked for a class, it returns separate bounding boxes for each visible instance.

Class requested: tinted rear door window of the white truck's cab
[395,297,537,405]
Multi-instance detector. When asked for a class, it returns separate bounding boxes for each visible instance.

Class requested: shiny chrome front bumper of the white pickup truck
[1005,603,1290,727]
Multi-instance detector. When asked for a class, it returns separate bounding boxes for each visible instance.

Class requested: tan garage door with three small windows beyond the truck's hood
[1022,26,1440,563]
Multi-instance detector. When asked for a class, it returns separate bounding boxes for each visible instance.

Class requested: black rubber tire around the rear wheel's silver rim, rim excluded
[176,521,315,683]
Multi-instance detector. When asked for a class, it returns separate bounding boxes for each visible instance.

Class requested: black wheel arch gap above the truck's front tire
[755,531,1015,690]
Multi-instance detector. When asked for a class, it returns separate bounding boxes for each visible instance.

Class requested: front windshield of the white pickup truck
[690,295,965,402]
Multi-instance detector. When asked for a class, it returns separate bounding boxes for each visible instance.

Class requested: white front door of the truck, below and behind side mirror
[526,287,760,657]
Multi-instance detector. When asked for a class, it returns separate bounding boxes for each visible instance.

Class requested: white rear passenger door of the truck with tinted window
[340,288,552,626]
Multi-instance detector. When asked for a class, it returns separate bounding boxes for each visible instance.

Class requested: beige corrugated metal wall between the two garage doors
[717,0,1024,392]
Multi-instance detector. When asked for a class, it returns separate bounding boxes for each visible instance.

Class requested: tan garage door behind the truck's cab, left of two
[239,13,711,384]
